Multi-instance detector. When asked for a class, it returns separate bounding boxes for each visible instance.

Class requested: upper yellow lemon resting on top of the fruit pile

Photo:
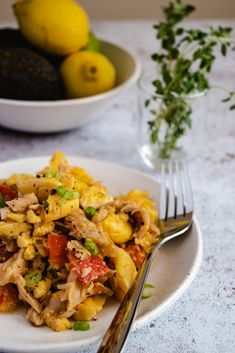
[14,0,89,55]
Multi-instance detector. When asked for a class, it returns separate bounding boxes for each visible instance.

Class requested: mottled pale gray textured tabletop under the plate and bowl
[0,21,235,353]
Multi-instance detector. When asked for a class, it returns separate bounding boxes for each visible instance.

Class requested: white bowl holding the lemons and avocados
[0,37,141,133]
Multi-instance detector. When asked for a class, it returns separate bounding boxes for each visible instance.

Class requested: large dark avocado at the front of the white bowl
[0,46,62,100]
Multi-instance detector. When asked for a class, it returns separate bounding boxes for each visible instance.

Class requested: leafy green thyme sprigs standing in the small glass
[148,0,235,158]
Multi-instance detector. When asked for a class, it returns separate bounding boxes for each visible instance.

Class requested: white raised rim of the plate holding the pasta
[0,155,203,353]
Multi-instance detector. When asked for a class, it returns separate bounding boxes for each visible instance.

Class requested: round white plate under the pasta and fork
[0,157,202,353]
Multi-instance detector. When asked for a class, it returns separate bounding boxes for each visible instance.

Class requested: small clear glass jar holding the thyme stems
[138,73,207,169]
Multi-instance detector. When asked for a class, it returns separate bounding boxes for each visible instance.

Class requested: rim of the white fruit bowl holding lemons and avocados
[0,21,141,107]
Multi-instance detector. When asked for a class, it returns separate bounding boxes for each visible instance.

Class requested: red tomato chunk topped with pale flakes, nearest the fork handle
[72,256,109,287]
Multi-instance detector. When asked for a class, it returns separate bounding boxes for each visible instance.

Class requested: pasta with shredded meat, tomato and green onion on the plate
[0,151,160,331]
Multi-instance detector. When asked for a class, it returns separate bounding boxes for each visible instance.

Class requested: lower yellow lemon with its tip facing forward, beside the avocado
[60,51,116,98]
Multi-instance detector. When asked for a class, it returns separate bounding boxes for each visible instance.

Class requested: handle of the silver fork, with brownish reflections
[97,251,155,353]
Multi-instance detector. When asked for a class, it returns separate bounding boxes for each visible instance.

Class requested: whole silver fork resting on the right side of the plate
[97,161,193,353]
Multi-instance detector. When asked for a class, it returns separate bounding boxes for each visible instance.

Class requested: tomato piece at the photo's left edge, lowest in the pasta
[0,283,19,313]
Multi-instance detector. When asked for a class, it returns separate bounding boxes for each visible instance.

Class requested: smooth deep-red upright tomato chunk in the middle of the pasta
[48,234,68,266]
